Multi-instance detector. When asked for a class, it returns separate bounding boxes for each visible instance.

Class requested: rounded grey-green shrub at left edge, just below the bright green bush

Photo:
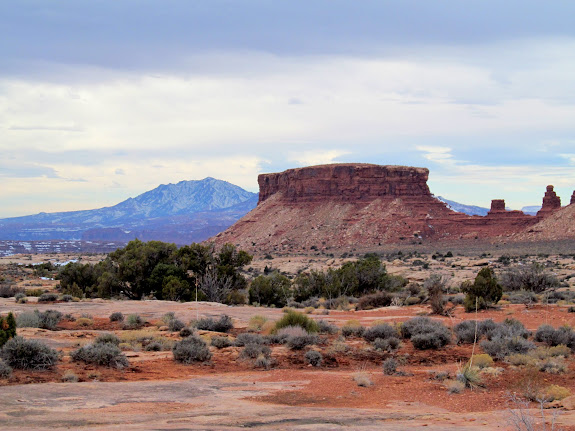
[0,336,60,370]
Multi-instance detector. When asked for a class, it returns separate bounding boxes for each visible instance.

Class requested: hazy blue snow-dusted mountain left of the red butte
[0,178,258,244]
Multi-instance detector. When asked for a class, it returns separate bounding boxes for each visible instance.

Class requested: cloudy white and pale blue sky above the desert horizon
[0,0,575,218]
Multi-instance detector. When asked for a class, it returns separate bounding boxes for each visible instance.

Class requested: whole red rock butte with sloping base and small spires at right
[213,163,561,252]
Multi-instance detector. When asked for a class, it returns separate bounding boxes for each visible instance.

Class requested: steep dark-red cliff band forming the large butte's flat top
[258,163,431,203]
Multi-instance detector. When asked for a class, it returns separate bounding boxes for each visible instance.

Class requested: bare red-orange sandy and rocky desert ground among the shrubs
[0,251,575,430]
